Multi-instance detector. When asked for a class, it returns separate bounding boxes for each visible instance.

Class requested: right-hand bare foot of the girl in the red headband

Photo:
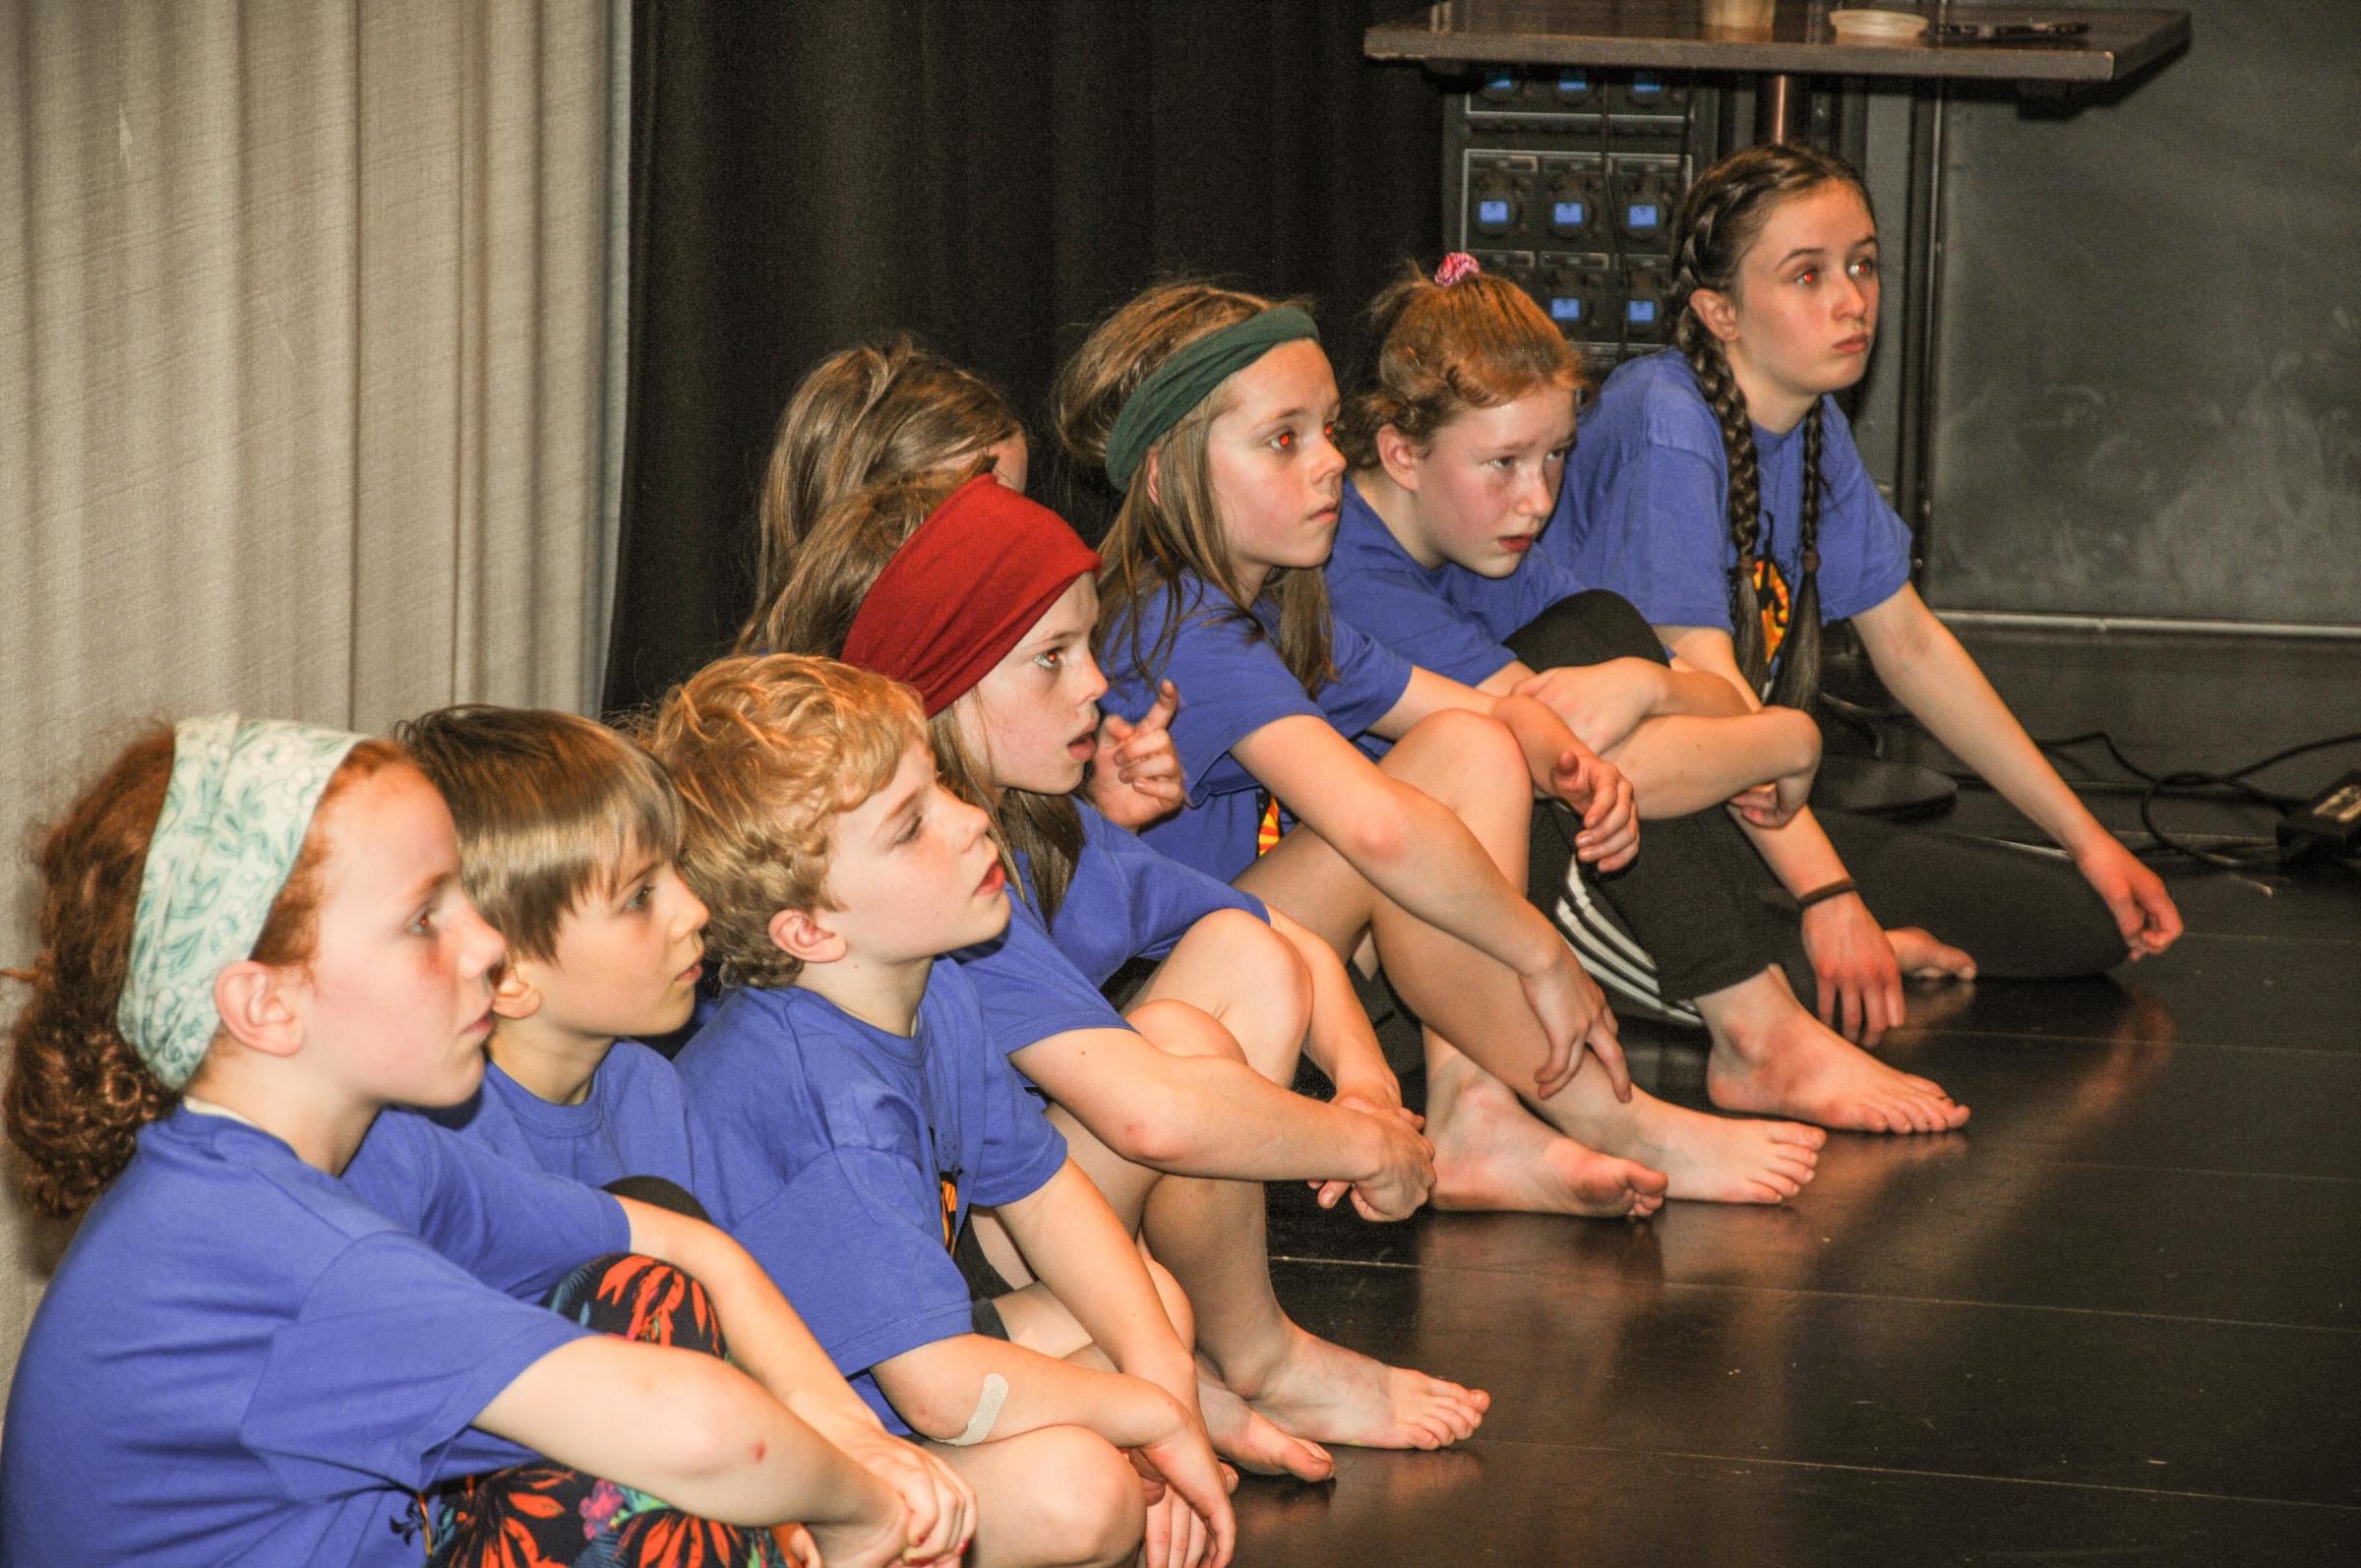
[1206,1325,1492,1457]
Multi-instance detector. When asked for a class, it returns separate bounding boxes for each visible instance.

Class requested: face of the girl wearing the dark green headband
[1204,337,1344,585]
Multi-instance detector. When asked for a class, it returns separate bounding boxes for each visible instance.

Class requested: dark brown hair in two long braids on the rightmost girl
[1671,144,1870,708]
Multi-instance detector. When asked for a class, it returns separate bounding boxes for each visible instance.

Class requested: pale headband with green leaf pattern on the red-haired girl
[116,713,361,1089]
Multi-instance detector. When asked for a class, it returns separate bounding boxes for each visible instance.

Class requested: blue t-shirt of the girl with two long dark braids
[1540,349,1910,665]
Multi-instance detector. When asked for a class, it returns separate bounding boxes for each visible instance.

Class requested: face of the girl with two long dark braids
[1724,182,1877,401]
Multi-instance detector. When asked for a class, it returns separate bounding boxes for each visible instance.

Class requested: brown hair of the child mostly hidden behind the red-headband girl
[739,337,1025,623]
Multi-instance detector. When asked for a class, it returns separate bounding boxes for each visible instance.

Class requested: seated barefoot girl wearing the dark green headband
[1056,283,1825,1214]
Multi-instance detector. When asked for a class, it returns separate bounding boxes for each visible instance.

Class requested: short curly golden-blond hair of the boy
[644,654,926,987]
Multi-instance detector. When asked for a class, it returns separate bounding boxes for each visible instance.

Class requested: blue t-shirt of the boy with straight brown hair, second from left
[425,1039,696,1192]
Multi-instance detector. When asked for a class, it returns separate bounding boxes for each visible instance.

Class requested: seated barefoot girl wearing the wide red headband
[757,462,1487,1478]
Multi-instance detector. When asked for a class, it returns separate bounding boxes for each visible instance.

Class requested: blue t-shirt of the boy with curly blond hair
[680,959,1064,1433]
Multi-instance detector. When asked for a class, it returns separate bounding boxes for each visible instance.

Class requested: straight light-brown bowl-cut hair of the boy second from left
[394,706,680,963]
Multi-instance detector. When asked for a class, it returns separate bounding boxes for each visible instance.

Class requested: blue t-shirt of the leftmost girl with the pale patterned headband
[0,1108,628,1568]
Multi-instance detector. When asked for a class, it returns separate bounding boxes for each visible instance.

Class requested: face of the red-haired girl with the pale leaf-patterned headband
[288,765,506,1105]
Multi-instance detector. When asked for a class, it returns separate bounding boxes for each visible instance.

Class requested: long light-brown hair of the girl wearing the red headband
[757,470,1081,921]
